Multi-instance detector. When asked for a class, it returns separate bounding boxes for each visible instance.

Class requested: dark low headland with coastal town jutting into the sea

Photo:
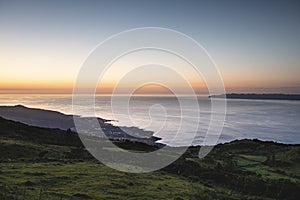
[0,105,160,145]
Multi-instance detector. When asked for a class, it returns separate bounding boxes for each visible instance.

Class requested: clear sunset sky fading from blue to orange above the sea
[0,0,300,93]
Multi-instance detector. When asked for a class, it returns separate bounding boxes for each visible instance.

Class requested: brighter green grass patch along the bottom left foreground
[0,162,229,199]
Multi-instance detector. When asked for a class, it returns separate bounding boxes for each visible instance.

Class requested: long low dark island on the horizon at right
[209,93,300,100]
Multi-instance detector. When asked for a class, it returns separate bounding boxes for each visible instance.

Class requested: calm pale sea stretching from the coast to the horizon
[0,95,300,146]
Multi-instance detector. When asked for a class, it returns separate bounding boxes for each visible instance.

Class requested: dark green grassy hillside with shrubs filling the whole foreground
[0,118,300,200]
